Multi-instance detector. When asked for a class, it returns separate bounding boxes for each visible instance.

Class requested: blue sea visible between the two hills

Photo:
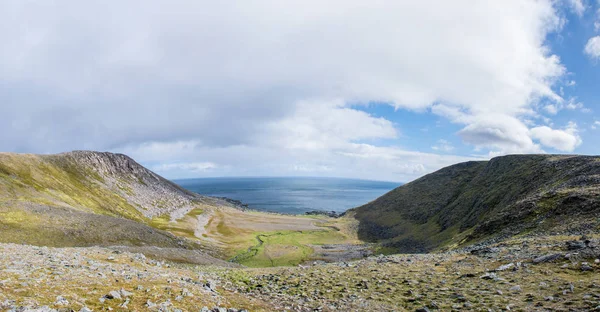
[175,178,400,214]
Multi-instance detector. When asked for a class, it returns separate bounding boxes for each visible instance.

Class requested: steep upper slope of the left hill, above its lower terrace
[0,151,201,221]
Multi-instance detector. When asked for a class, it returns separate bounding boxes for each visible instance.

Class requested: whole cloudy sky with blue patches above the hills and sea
[0,0,600,182]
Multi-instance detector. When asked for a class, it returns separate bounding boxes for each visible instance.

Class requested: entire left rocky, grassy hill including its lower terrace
[0,151,225,263]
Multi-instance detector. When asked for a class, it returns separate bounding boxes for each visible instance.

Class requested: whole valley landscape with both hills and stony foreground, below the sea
[0,151,600,312]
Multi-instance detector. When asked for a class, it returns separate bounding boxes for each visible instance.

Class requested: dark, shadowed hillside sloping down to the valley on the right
[349,155,600,252]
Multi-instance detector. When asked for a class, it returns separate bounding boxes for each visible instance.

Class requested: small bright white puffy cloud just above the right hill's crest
[531,122,582,152]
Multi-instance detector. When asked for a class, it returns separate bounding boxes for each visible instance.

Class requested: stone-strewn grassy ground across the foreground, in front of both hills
[0,236,600,311]
